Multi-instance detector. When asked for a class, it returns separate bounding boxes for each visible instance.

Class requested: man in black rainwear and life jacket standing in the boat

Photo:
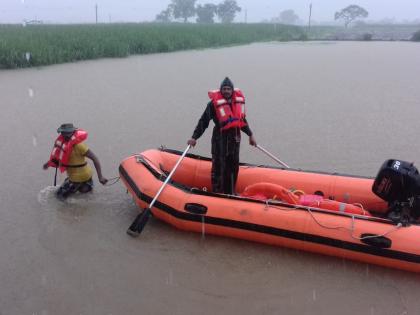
[188,77,257,195]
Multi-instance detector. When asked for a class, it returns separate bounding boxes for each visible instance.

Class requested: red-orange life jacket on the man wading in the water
[48,129,88,173]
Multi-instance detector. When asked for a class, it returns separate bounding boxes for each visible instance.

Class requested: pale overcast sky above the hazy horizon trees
[0,0,420,24]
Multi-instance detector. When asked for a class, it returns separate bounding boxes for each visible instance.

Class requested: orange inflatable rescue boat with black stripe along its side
[119,149,420,272]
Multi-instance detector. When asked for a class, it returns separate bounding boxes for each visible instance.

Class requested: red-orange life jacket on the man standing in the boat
[208,89,246,130]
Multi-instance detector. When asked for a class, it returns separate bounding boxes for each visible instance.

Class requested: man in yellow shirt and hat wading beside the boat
[43,124,108,200]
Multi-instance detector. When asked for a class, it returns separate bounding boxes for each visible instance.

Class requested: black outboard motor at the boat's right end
[372,160,420,225]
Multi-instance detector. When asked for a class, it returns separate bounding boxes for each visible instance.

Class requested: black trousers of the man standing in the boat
[211,130,241,195]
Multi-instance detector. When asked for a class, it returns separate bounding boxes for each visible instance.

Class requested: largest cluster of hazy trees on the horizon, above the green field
[155,0,241,23]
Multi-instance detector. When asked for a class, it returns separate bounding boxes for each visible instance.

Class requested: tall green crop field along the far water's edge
[0,23,305,69]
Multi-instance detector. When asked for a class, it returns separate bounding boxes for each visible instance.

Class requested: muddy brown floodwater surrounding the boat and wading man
[0,42,420,315]
